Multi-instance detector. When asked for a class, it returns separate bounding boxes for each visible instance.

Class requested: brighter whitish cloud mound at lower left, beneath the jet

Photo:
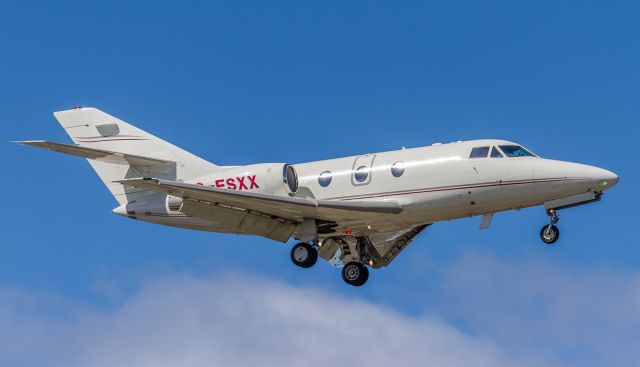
[0,274,548,367]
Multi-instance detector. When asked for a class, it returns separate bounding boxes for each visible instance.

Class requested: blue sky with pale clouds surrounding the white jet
[0,1,640,366]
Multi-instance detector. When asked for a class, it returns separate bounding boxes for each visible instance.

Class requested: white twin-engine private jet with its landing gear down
[18,107,618,286]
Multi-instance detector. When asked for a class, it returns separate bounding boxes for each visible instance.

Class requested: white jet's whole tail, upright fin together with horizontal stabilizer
[18,107,221,207]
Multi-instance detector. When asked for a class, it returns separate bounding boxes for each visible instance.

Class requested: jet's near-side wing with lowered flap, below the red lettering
[116,178,402,241]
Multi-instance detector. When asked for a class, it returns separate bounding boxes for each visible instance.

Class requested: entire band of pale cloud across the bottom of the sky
[0,253,640,367]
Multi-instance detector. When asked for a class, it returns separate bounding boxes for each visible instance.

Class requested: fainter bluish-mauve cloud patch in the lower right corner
[428,252,640,366]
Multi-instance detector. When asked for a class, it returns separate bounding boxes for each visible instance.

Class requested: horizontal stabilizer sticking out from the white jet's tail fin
[16,140,175,166]
